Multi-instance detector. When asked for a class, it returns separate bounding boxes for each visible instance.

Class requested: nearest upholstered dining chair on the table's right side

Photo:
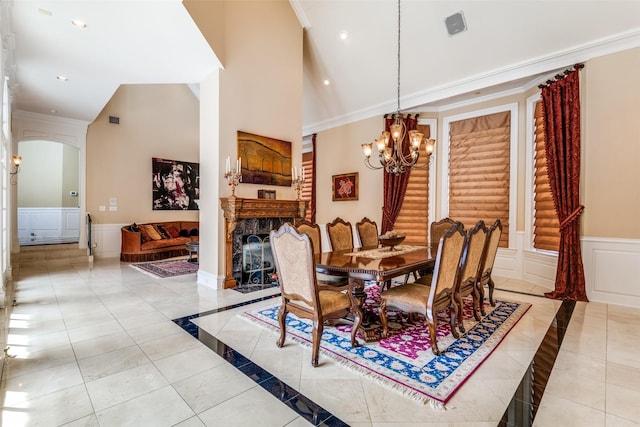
[380,222,465,355]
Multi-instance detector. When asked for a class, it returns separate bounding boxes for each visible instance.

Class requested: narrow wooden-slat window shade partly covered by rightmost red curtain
[533,101,560,252]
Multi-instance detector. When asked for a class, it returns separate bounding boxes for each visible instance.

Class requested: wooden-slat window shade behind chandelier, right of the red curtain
[393,124,431,245]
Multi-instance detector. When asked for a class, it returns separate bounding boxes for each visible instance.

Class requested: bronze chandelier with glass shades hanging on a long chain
[362,0,435,175]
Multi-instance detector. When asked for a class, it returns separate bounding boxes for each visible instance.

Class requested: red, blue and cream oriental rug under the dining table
[242,285,531,405]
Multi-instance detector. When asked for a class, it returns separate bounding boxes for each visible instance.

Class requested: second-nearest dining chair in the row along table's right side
[455,220,487,333]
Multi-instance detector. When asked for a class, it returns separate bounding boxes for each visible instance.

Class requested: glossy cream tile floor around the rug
[1,247,640,427]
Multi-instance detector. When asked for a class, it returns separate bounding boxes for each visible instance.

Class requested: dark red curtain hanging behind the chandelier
[380,115,418,234]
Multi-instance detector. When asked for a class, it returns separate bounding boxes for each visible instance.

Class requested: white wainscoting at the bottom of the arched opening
[18,208,80,246]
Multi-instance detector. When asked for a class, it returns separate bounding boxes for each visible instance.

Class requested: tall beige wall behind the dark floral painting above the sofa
[87,84,200,224]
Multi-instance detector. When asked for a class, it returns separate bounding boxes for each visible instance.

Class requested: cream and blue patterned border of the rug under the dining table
[240,300,531,409]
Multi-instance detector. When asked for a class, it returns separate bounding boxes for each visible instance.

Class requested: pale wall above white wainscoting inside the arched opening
[17,141,78,208]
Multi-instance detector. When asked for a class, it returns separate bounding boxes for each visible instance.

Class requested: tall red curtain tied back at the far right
[542,69,588,301]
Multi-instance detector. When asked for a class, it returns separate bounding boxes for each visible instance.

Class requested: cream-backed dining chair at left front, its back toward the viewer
[269,223,362,367]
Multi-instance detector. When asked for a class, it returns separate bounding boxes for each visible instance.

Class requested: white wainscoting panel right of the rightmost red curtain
[582,237,640,307]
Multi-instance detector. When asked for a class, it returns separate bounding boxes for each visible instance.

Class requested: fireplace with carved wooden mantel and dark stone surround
[220,196,308,288]
